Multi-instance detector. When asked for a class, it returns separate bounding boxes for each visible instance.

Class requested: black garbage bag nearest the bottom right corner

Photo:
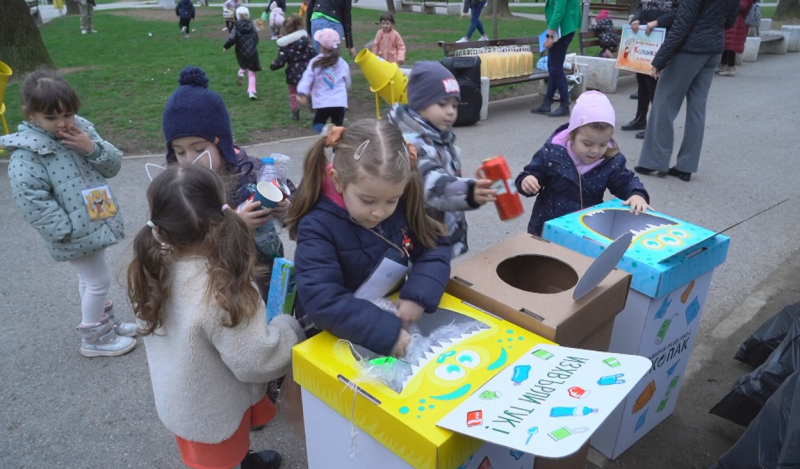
[710,370,800,469]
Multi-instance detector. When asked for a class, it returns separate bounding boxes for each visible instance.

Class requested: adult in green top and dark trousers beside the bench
[531,0,581,117]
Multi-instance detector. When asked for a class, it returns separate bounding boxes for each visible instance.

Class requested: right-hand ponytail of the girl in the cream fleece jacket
[206,208,261,327]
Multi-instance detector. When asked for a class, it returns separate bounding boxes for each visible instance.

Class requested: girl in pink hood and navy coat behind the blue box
[516,91,650,236]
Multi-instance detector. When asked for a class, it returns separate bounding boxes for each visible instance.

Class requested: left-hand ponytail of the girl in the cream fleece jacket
[128,225,172,335]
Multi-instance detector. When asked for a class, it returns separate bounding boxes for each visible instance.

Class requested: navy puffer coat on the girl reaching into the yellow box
[294,195,451,355]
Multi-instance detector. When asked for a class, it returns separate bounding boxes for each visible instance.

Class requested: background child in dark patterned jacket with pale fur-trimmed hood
[269,15,317,121]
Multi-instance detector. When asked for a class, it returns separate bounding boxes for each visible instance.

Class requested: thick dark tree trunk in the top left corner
[0,0,55,76]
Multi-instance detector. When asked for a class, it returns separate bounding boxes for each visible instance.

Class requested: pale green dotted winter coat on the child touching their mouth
[0,116,125,261]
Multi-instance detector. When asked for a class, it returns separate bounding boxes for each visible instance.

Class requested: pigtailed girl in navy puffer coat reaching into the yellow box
[286,119,451,356]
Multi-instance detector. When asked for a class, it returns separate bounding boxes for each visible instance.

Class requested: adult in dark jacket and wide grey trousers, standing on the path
[633,0,739,182]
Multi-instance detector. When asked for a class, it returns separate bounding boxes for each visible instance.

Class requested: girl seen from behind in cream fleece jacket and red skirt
[128,165,303,469]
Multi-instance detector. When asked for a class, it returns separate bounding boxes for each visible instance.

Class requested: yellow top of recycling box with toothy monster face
[292,294,553,469]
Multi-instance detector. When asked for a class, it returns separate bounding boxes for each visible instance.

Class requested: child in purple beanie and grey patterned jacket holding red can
[389,62,497,257]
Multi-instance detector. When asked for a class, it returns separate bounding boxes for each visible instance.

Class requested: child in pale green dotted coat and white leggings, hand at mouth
[0,71,136,357]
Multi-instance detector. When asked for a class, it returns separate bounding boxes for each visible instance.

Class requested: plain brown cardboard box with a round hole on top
[447,233,631,351]
